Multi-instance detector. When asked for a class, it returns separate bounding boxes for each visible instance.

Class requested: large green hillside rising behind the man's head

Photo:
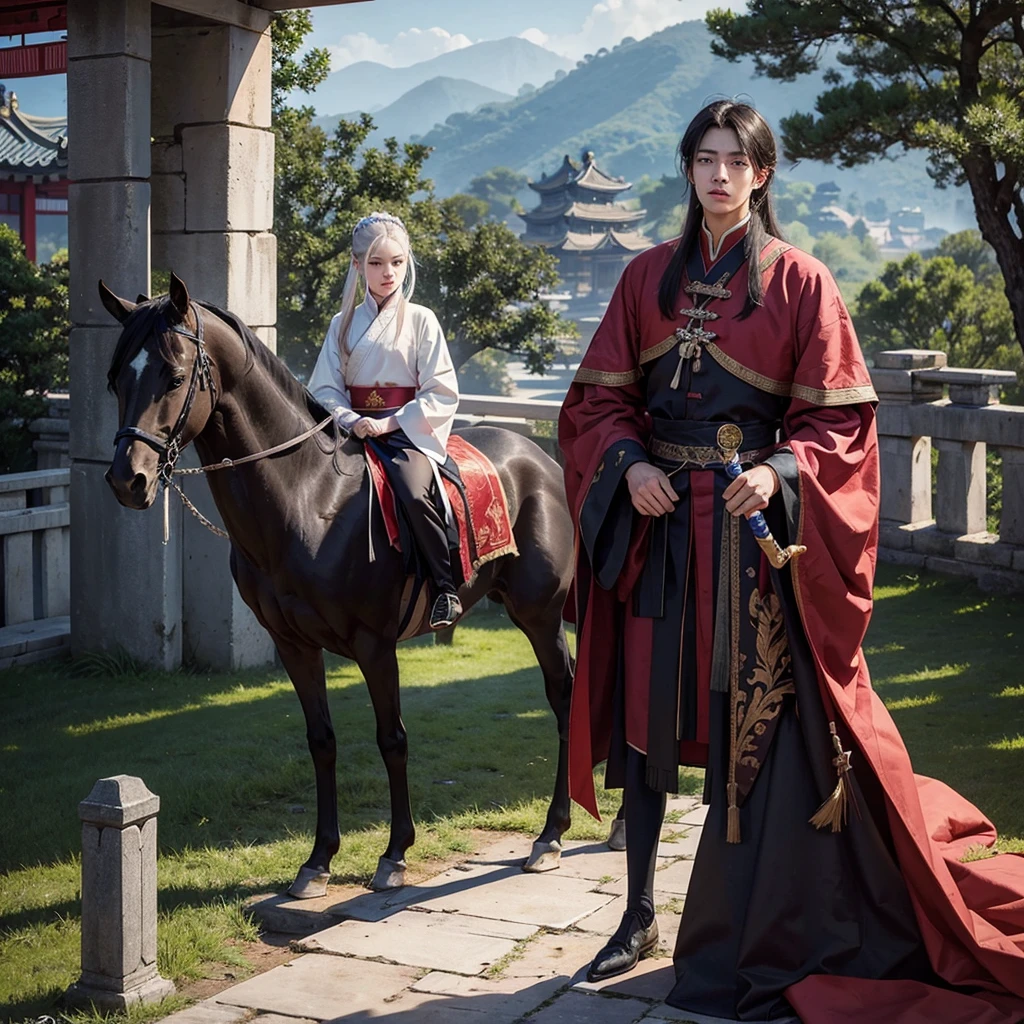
[413,22,953,222]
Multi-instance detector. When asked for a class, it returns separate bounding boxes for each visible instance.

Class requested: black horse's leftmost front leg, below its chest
[276,640,340,899]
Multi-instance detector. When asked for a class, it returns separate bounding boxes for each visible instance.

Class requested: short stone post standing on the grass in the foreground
[66,775,174,1010]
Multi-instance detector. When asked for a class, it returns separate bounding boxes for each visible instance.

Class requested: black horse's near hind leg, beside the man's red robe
[506,598,572,871]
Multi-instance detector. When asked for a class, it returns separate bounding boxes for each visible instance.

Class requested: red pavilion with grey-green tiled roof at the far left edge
[0,85,68,260]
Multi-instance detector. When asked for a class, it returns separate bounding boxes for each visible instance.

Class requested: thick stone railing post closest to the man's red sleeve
[871,349,946,550]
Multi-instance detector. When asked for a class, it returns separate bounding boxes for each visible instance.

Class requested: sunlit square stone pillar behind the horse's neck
[153,19,276,669]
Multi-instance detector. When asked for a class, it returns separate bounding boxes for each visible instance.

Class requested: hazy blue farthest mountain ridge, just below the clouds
[301,37,572,117]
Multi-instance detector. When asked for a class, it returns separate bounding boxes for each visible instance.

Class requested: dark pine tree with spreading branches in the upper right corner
[708,0,1024,346]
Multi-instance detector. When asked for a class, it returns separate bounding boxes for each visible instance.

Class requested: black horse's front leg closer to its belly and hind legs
[352,632,416,889]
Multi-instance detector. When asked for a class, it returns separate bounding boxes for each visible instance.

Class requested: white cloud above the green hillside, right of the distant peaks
[519,0,746,60]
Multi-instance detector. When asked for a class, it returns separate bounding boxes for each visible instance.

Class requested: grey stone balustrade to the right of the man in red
[871,349,1024,590]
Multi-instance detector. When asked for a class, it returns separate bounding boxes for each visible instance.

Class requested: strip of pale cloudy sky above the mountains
[307,0,745,71]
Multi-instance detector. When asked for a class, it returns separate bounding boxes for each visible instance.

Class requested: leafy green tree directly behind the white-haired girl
[274,24,571,373]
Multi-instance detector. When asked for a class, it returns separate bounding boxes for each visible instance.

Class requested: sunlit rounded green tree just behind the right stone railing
[854,231,1021,369]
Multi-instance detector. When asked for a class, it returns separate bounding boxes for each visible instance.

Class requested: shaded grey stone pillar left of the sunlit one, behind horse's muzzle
[68,0,181,669]
